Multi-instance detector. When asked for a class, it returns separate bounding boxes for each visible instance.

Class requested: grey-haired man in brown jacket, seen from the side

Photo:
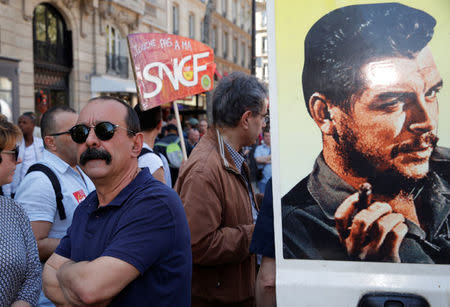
[175,73,267,307]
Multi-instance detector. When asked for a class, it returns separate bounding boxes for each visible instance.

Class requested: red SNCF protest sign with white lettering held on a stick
[128,33,215,110]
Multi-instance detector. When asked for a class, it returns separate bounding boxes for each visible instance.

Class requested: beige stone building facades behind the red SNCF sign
[0,0,251,121]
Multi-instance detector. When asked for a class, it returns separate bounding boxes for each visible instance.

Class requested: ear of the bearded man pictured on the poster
[309,92,335,135]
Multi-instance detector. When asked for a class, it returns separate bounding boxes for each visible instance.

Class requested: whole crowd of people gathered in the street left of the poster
[0,73,270,306]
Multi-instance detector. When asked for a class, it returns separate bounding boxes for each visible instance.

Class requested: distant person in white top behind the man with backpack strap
[3,112,44,198]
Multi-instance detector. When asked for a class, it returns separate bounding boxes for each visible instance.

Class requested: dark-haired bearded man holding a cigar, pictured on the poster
[282,3,450,263]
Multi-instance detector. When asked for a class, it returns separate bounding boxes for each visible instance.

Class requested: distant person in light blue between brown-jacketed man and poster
[254,126,272,193]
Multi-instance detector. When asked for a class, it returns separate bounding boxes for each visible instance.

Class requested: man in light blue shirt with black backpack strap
[15,106,95,307]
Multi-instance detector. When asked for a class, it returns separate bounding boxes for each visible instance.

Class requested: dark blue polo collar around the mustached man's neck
[86,167,156,210]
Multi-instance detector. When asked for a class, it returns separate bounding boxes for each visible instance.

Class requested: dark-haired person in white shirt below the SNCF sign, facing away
[134,104,172,187]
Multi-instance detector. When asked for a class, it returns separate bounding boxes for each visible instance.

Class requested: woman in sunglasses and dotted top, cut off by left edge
[0,117,41,307]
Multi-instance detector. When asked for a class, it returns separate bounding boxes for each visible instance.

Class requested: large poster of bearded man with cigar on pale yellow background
[269,0,450,264]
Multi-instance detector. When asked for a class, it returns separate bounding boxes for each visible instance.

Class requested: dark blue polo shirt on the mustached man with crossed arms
[55,168,192,306]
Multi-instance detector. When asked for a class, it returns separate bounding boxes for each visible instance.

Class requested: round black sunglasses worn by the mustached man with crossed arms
[69,122,136,144]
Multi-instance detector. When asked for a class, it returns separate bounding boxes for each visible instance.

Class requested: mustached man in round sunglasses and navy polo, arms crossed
[43,96,192,306]
